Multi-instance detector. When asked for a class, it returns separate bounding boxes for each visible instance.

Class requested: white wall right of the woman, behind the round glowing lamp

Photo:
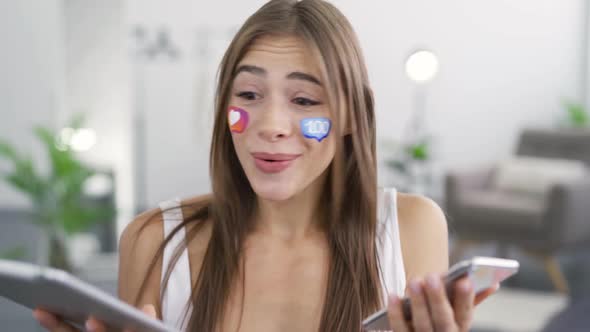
[338,0,585,171]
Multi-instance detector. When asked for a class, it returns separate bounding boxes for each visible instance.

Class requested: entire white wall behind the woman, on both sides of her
[0,0,587,215]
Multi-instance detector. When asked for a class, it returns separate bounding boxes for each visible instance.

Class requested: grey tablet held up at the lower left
[0,260,178,332]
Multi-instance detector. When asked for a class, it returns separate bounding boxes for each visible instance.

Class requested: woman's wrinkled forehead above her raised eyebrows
[238,36,320,77]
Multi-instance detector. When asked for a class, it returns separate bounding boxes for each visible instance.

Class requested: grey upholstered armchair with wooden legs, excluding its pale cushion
[445,129,590,293]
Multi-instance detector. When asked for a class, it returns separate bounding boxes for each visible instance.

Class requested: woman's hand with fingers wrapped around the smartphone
[388,274,499,332]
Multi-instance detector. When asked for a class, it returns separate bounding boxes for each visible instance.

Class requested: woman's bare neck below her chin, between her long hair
[254,172,325,241]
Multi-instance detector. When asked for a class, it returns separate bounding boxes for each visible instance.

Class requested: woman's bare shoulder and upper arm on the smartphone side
[397,193,449,279]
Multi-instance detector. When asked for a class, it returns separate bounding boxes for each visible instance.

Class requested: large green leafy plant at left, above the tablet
[0,116,114,271]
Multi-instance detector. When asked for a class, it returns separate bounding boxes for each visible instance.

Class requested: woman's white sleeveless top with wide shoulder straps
[160,188,406,331]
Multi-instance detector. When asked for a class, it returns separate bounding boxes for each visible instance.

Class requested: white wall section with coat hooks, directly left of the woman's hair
[127,0,264,206]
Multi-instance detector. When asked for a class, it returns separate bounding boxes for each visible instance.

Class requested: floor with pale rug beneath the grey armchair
[463,240,590,332]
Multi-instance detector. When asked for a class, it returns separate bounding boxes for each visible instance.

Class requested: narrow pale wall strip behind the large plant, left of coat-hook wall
[65,0,135,239]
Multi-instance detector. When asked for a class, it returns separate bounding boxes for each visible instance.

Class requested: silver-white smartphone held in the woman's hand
[363,257,520,331]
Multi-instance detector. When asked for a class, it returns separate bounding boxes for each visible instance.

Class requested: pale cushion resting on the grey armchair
[493,156,588,195]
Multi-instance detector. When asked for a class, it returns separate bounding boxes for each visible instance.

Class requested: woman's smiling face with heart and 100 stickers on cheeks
[227,37,337,201]
